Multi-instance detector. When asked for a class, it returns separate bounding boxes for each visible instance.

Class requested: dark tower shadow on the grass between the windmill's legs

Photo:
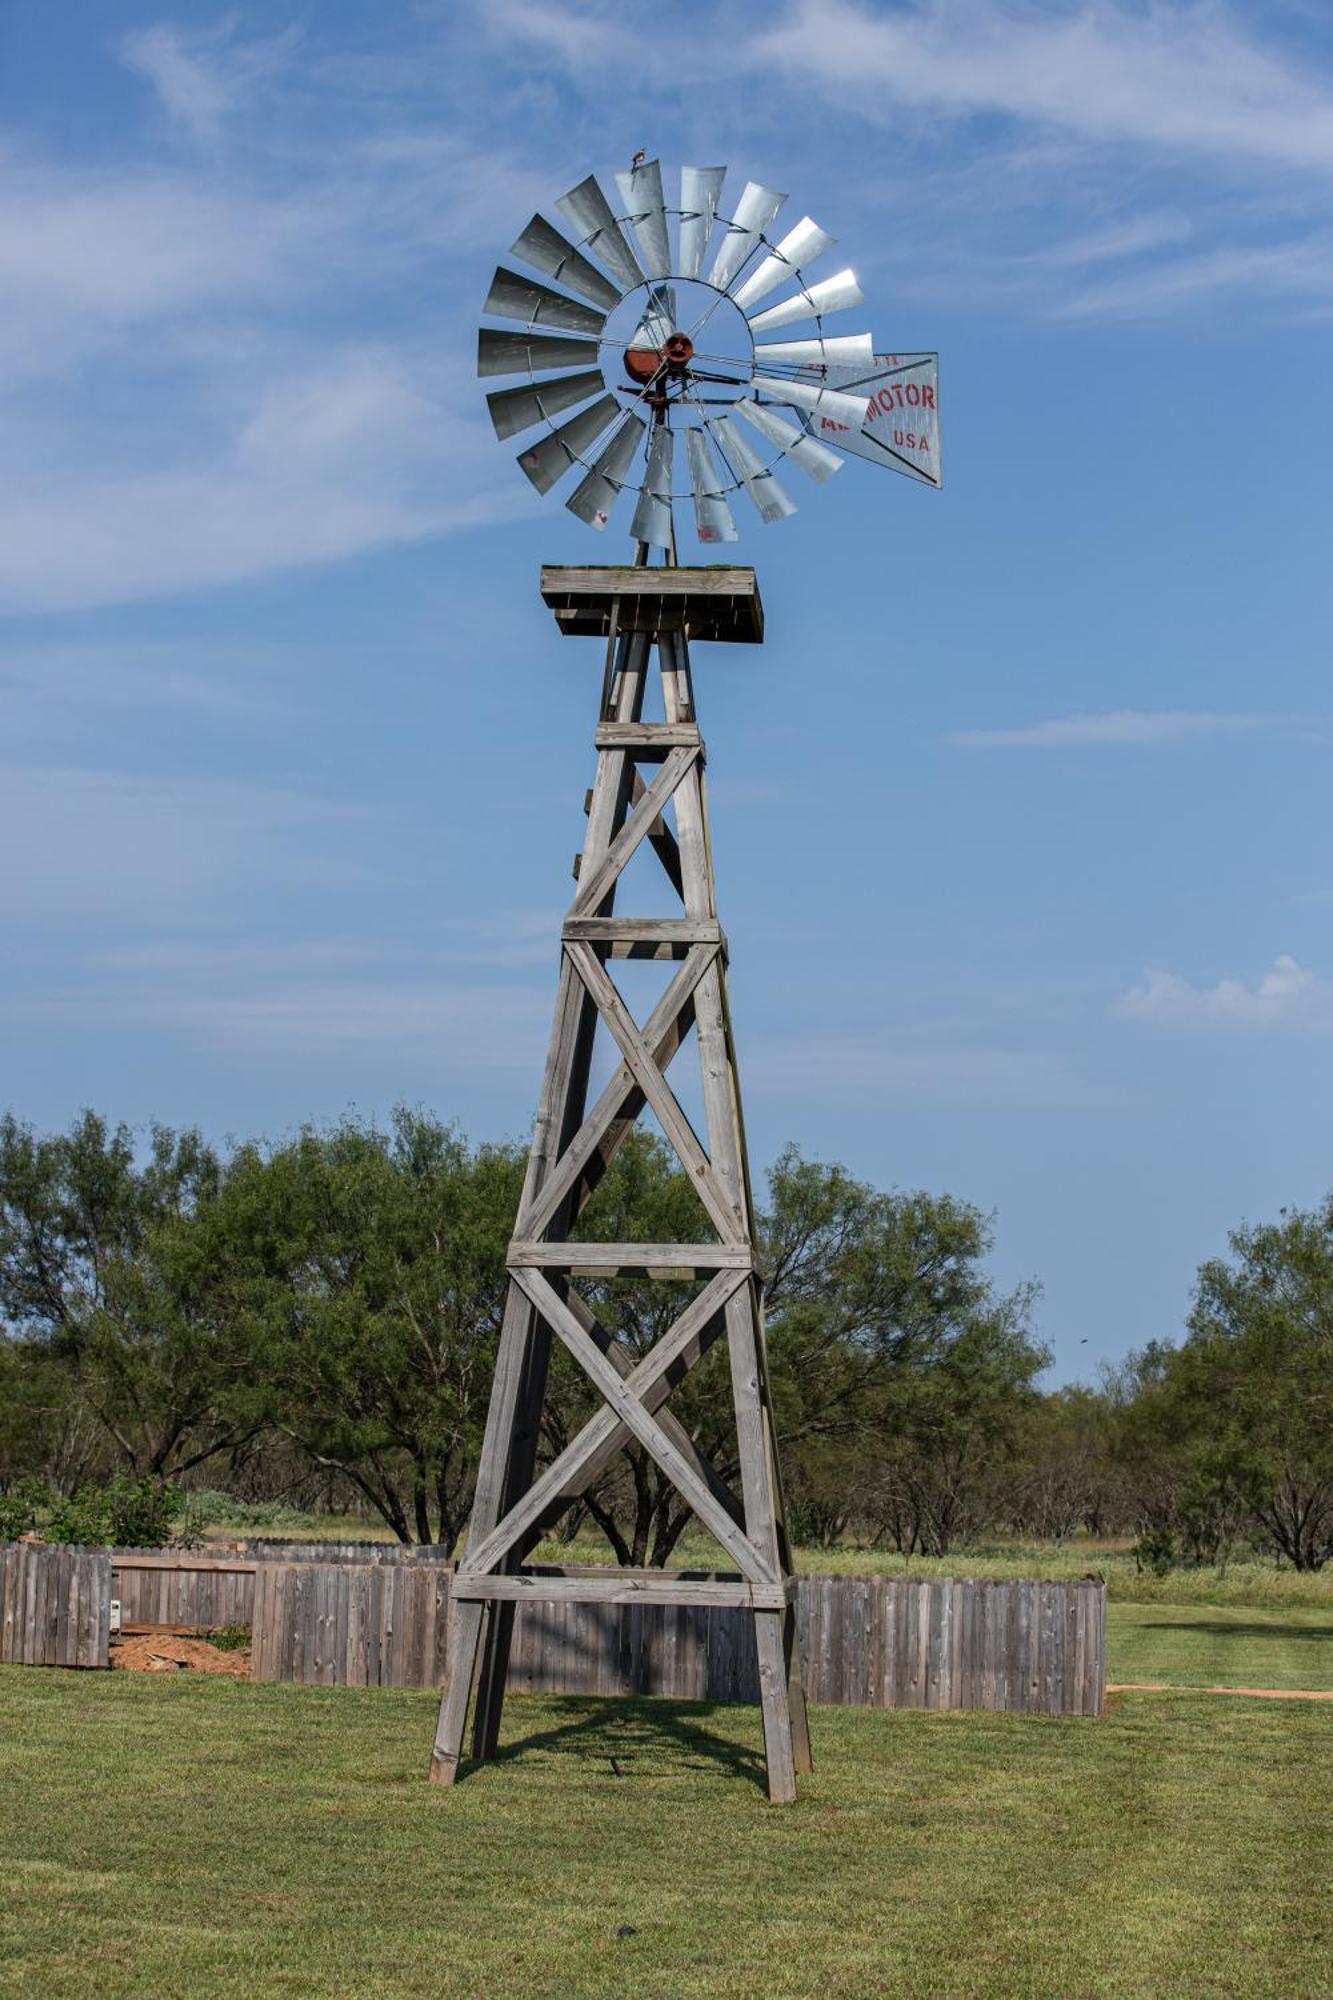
[458,1696,769,1794]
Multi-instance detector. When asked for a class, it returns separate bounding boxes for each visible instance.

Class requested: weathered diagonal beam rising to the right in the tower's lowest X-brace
[466,1270,747,1570]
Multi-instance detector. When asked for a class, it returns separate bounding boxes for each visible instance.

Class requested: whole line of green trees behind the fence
[0,1110,1333,1570]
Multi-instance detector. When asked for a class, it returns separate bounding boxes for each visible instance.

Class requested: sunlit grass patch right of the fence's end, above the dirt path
[1107,1604,1333,1690]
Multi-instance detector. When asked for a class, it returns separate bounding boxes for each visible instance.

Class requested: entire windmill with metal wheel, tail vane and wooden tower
[430,156,941,1800]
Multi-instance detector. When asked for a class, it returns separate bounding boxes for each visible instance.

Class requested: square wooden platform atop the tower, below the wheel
[542,564,765,646]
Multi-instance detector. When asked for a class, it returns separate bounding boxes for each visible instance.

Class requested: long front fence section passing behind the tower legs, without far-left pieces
[254,1564,1105,1716]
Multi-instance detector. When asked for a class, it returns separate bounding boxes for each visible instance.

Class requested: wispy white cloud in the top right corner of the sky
[753,0,1333,172]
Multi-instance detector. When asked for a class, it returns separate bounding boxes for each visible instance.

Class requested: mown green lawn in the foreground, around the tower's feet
[0,1668,1333,2000]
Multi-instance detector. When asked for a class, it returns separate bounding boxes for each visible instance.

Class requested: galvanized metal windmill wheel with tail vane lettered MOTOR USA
[476,154,943,552]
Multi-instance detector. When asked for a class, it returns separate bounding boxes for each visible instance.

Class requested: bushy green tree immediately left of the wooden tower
[190,1110,522,1546]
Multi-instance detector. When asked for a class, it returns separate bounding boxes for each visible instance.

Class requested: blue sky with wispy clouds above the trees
[0,0,1333,1378]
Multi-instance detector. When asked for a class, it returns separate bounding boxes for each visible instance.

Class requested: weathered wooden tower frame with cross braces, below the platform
[430,570,811,1800]
